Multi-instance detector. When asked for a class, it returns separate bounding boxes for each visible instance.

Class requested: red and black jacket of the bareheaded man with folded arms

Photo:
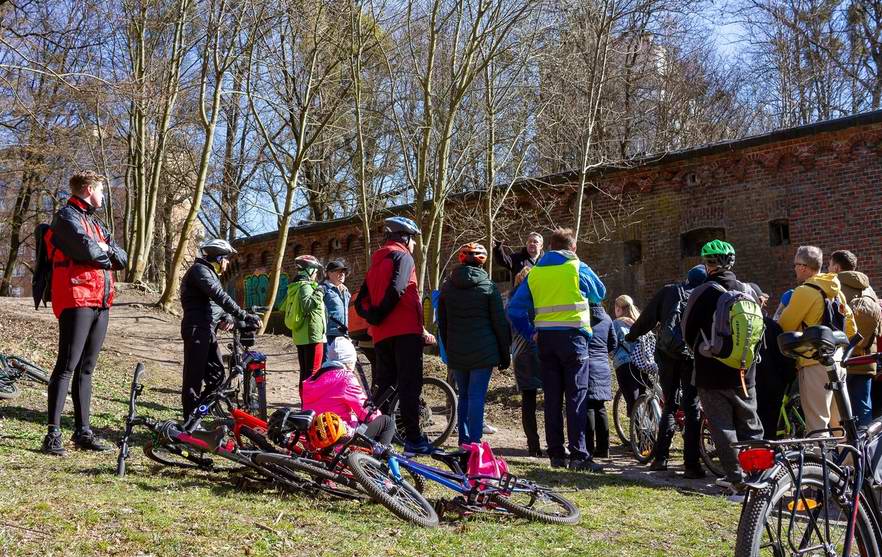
[45,197,127,317]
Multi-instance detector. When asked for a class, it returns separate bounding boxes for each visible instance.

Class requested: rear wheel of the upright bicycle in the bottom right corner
[735,462,879,557]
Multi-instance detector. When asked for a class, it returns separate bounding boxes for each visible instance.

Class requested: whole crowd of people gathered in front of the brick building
[36,172,882,500]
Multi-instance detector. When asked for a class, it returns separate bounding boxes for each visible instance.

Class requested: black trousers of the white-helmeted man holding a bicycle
[181,327,224,420]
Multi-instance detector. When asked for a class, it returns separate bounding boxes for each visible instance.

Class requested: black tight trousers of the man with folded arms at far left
[48,308,110,431]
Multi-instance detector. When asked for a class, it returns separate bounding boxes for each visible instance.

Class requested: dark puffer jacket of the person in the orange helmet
[438,265,511,371]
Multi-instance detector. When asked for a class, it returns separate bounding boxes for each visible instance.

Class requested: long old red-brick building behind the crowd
[234,111,882,314]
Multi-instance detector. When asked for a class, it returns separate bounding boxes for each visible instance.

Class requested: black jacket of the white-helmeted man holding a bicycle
[181,258,246,329]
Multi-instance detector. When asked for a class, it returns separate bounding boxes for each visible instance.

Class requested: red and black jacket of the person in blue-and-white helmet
[355,241,423,343]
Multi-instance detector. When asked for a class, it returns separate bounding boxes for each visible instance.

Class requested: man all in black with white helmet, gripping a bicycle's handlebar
[181,238,260,420]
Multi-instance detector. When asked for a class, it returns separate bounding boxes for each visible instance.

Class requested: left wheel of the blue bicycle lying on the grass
[346,452,438,528]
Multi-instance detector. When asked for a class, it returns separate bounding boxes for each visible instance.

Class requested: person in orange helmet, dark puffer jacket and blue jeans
[438,243,511,444]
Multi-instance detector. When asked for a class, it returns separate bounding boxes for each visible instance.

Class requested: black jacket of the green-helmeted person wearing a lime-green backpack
[684,271,756,391]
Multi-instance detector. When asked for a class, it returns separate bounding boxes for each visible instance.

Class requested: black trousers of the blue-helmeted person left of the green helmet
[654,353,701,466]
